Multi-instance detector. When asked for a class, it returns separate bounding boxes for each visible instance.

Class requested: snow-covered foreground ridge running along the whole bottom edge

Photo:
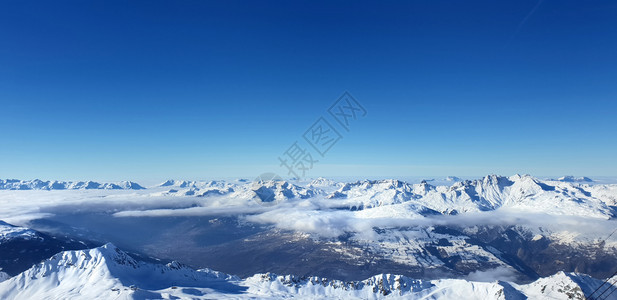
[0,244,612,299]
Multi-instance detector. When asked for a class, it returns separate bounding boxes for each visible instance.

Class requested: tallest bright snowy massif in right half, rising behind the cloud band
[318,175,616,219]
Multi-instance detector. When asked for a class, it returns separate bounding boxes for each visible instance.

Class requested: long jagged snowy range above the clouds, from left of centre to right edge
[148,175,617,219]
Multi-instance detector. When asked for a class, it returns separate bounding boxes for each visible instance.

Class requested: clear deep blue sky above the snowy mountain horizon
[0,0,617,180]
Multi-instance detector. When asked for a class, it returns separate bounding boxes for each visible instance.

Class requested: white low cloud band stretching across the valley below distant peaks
[0,191,617,243]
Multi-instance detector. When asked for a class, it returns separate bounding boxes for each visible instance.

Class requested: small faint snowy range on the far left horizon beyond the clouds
[0,179,144,190]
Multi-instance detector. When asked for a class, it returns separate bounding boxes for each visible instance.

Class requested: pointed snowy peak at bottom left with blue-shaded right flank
[0,244,236,299]
